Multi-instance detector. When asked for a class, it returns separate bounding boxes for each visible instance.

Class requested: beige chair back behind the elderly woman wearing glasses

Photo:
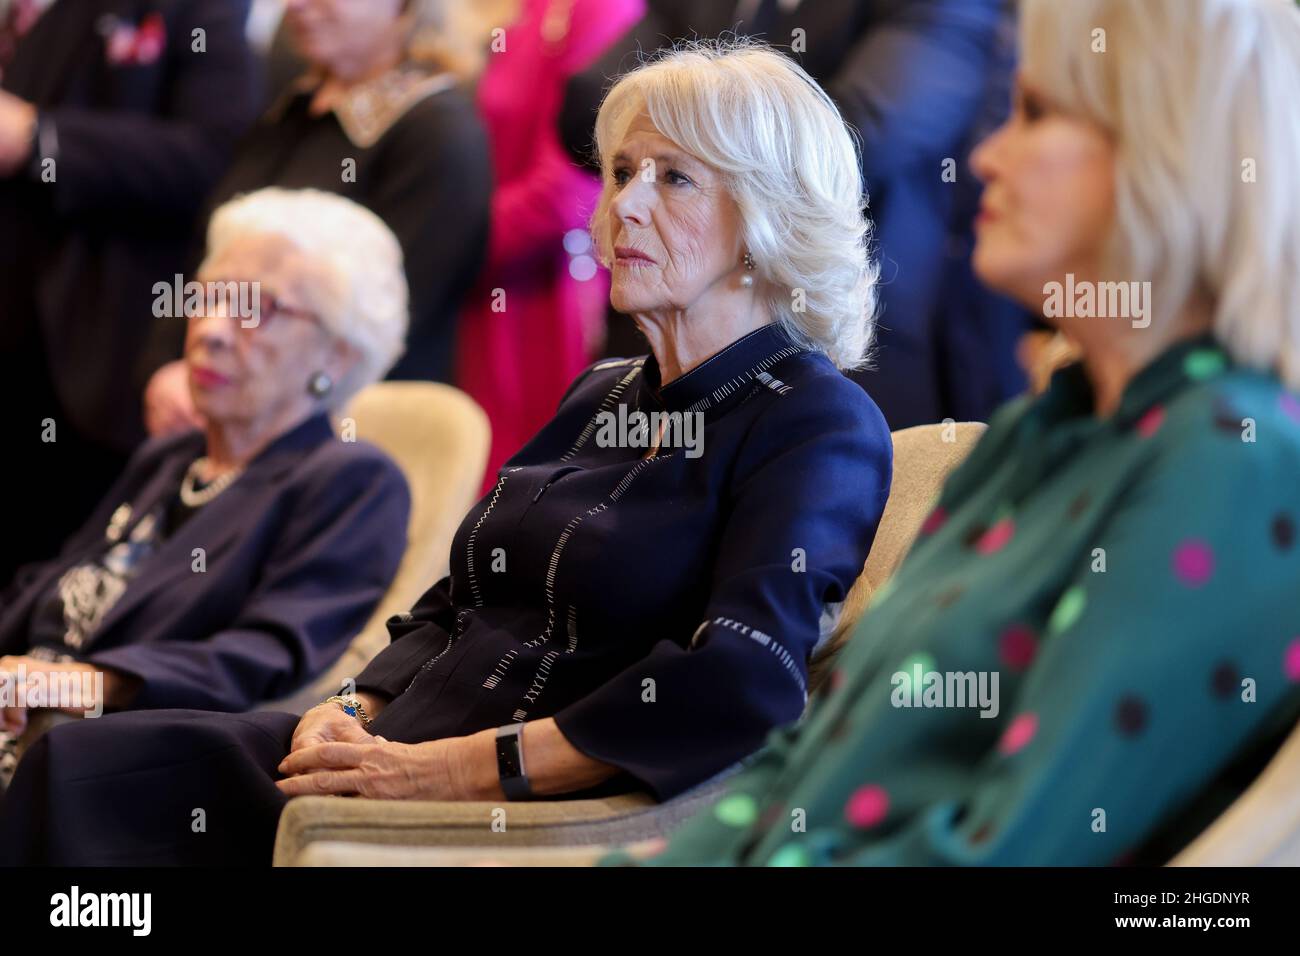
[259,381,490,714]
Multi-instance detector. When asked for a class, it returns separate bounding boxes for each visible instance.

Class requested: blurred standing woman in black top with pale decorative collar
[146,0,491,434]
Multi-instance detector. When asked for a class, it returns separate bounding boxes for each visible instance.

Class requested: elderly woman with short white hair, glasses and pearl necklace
[0,190,410,788]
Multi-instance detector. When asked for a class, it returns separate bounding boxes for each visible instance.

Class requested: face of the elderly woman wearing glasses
[185,235,359,425]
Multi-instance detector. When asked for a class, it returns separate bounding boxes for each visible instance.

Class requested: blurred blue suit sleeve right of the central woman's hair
[826,0,1004,187]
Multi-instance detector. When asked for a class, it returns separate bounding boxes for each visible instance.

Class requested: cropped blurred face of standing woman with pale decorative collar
[285,0,404,73]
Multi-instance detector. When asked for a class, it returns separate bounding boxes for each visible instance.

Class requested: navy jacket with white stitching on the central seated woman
[358,326,893,799]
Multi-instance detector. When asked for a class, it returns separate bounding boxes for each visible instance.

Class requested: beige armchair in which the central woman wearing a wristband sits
[274,423,984,866]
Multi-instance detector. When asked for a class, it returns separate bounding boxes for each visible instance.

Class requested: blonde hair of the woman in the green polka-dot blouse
[1022,0,1300,389]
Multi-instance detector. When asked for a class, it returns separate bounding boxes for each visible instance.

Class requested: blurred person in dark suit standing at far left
[0,0,257,580]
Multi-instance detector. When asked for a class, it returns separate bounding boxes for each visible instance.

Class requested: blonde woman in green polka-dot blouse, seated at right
[621,0,1300,865]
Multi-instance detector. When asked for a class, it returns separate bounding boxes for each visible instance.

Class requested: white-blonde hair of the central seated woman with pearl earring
[592,39,879,369]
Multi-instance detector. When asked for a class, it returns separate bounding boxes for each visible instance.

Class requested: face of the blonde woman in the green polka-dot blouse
[971,77,1115,312]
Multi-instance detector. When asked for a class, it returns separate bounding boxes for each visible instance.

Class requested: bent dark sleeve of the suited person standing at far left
[42,0,259,217]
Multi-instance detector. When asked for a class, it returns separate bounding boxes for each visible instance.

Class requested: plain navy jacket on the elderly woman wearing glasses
[0,415,410,710]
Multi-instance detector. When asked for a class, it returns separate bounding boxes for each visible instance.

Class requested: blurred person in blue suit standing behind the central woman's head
[560,0,1023,429]
